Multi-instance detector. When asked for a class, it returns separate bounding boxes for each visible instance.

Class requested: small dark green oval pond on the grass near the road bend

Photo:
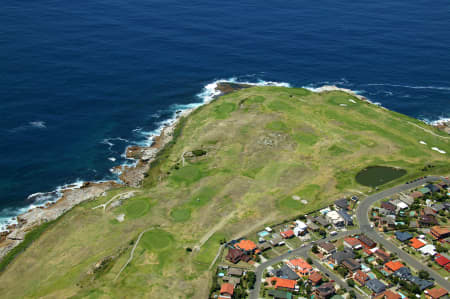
[355,166,406,187]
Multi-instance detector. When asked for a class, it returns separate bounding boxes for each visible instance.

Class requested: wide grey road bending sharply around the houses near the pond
[356,176,450,290]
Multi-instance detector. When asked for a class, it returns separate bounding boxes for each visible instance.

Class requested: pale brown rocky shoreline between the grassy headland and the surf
[0,82,444,259]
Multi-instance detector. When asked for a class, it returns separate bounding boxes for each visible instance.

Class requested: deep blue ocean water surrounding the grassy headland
[0,0,450,225]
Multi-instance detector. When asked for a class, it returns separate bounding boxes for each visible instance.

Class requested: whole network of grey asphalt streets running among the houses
[250,176,450,299]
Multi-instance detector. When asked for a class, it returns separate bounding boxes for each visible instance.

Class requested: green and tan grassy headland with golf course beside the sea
[0,87,450,298]
